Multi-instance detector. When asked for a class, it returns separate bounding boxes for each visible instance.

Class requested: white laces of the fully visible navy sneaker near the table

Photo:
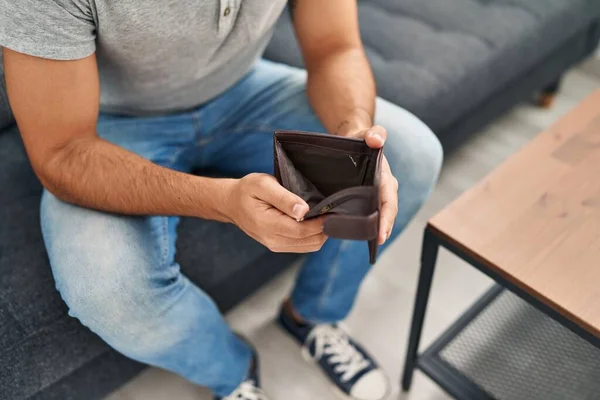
[307,324,371,382]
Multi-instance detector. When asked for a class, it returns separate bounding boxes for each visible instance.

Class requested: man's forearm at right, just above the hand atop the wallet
[307,47,376,135]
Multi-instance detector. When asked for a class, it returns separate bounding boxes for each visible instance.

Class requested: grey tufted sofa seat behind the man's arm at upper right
[266,0,600,131]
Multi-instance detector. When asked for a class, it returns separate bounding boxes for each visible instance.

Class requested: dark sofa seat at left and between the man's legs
[0,127,278,399]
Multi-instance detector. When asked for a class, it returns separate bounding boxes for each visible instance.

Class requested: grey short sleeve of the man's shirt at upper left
[0,0,96,60]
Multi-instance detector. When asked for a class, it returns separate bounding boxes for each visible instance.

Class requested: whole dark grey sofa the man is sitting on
[0,0,600,400]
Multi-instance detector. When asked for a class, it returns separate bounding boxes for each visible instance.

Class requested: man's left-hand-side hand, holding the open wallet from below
[224,174,327,253]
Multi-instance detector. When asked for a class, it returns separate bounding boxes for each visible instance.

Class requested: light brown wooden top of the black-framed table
[429,91,600,337]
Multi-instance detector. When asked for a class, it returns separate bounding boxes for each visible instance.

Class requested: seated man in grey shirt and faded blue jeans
[0,0,442,400]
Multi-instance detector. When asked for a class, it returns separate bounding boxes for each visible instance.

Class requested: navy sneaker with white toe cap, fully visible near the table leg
[279,309,390,400]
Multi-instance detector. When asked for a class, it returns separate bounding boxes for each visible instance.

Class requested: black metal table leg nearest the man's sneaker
[402,229,440,391]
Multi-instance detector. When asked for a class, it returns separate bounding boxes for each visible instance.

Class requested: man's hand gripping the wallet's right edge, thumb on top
[338,123,398,244]
